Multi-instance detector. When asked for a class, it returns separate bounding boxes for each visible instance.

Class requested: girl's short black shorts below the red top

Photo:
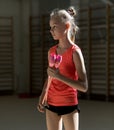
[45,105,80,115]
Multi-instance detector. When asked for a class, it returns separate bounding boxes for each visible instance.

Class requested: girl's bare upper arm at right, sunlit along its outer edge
[73,49,87,81]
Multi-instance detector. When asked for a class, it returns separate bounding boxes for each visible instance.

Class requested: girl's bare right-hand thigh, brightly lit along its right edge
[62,110,79,130]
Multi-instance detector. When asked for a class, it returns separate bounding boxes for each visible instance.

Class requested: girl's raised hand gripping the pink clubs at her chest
[47,67,60,78]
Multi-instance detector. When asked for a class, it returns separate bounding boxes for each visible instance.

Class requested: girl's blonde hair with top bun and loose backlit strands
[50,6,79,42]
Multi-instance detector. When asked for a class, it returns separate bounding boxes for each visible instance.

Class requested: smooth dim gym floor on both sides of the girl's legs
[0,95,114,130]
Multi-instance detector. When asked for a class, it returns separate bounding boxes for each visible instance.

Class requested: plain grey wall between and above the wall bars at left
[0,0,73,93]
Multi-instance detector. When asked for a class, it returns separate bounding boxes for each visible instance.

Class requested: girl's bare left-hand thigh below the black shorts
[46,109,62,130]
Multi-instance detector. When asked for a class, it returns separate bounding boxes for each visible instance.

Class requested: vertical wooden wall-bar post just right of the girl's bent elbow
[88,7,91,99]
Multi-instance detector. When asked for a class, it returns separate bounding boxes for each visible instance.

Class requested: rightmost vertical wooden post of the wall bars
[106,4,110,100]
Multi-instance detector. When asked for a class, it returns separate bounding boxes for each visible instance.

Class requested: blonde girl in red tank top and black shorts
[38,7,88,130]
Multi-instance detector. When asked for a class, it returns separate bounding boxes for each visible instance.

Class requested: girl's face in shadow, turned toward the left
[50,18,66,40]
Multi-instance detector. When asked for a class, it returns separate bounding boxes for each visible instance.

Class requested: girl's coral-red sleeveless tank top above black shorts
[47,45,79,106]
